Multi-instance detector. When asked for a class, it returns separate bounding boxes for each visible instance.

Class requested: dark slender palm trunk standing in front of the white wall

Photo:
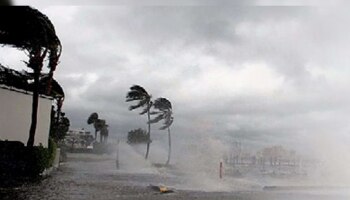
[27,70,40,147]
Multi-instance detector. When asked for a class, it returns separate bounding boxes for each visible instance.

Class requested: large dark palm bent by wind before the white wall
[0,6,62,147]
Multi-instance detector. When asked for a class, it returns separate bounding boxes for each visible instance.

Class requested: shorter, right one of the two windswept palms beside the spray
[149,98,174,165]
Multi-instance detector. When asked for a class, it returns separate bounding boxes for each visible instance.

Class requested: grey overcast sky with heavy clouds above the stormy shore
[0,0,350,157]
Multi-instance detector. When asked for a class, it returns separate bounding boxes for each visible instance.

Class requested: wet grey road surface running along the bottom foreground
[0,154,349,200]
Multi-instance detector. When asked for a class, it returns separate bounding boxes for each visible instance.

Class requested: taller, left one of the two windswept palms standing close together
[126,85,152,159]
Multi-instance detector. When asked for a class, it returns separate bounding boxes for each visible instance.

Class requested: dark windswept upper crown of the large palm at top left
[0,6,61,51]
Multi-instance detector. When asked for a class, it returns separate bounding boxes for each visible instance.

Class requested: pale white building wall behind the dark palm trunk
[0,87,52,147]
